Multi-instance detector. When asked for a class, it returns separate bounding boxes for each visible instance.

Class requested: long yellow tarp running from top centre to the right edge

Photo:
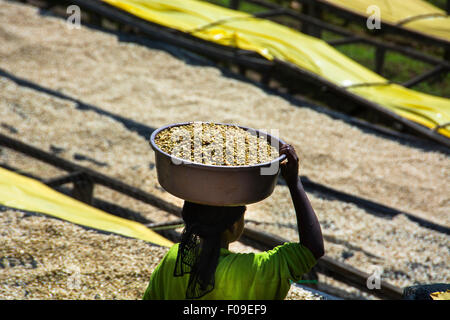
[103,0,450,137]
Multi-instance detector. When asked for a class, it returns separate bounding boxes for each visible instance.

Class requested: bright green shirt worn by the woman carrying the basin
[143,242,316,300]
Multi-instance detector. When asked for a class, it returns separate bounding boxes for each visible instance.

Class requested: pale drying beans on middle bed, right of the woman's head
[246,186,450,287]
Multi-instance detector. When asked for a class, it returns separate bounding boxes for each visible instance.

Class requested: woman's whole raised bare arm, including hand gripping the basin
[280,144,325,259]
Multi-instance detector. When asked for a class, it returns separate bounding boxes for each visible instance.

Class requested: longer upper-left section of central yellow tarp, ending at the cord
[104,0,386,85]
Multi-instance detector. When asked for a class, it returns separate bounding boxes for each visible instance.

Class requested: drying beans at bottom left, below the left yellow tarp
[0,209,320,300]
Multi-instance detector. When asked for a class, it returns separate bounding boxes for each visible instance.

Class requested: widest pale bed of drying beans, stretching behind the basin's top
[0,0,450,226]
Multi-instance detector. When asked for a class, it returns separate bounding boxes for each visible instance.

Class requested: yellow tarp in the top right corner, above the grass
[319,0,450,41]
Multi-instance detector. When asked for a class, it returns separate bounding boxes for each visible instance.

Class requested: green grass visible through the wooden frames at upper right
[203,0,450,98]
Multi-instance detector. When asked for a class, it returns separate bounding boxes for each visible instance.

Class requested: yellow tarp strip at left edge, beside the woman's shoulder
[0,168,173,247]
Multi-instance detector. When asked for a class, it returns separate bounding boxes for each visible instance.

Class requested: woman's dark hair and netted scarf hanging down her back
[174,201,246,299]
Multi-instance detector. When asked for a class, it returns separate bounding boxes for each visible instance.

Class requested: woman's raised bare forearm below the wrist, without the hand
[288,178,324,259]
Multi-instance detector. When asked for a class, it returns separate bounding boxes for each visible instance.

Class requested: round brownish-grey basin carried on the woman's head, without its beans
[150,122,286,206]
